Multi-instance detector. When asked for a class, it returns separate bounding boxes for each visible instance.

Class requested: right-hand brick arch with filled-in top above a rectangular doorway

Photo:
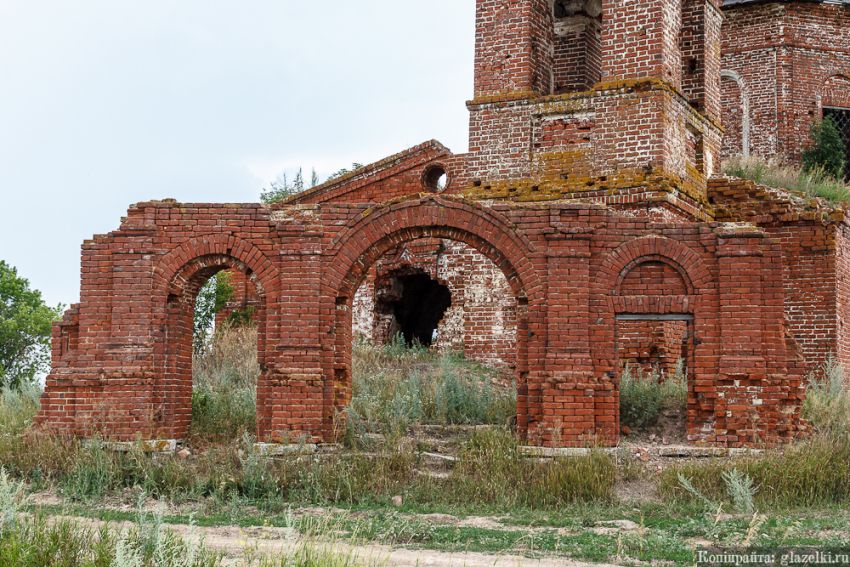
[593,236,717,443]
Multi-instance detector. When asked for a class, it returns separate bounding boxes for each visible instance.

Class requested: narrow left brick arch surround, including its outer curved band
[147,235,278,439]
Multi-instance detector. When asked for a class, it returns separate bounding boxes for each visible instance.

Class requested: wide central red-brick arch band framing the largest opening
[322,197,546,442]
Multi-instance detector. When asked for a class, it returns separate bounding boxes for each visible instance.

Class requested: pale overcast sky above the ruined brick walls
[0,0,475,310]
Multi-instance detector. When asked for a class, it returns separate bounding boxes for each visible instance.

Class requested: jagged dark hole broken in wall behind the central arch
[378,272,452,346]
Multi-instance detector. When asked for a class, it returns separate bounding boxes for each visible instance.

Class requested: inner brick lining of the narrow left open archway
[153,254,266,439]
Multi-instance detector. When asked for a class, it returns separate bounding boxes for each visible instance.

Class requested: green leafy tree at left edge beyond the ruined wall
[0,260,62,388]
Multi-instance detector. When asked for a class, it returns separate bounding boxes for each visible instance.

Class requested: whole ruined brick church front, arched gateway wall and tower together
[38,0,850,452]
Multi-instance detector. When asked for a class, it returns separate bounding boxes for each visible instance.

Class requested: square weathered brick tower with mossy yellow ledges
[467,0,722,219]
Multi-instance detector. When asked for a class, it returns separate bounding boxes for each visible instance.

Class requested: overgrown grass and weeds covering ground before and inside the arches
[0,334,850,566]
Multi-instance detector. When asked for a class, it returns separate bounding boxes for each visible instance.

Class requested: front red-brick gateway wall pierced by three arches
[39,197,801,446]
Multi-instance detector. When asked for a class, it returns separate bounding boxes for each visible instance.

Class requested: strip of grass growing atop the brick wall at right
[723,157,850,204]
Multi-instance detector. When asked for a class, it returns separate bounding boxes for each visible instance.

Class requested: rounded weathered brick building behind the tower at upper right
[722,1,850,160]
